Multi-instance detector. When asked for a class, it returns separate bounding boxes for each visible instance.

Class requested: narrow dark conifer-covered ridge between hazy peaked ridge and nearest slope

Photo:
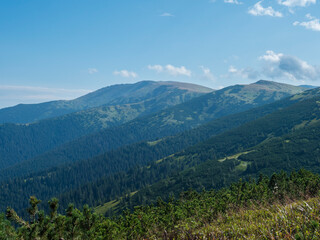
[0,91,298,213]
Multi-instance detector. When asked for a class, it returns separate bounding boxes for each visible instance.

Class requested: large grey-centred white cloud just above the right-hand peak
[259,51,320,81]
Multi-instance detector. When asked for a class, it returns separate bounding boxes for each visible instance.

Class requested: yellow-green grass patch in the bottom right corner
[198,198,320,240]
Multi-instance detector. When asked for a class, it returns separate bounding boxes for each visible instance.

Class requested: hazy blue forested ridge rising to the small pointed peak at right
[0,81,305,176]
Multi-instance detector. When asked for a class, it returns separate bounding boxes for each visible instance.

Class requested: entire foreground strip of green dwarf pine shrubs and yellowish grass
[0,170,320,240]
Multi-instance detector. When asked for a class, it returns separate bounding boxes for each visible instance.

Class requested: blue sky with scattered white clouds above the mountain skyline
[0,0,320,108]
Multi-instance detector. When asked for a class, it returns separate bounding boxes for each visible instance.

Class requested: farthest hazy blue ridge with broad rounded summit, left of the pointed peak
[0,81,212,123]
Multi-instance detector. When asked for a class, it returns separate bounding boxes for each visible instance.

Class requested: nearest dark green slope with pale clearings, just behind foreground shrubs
[51,89,320,214]
